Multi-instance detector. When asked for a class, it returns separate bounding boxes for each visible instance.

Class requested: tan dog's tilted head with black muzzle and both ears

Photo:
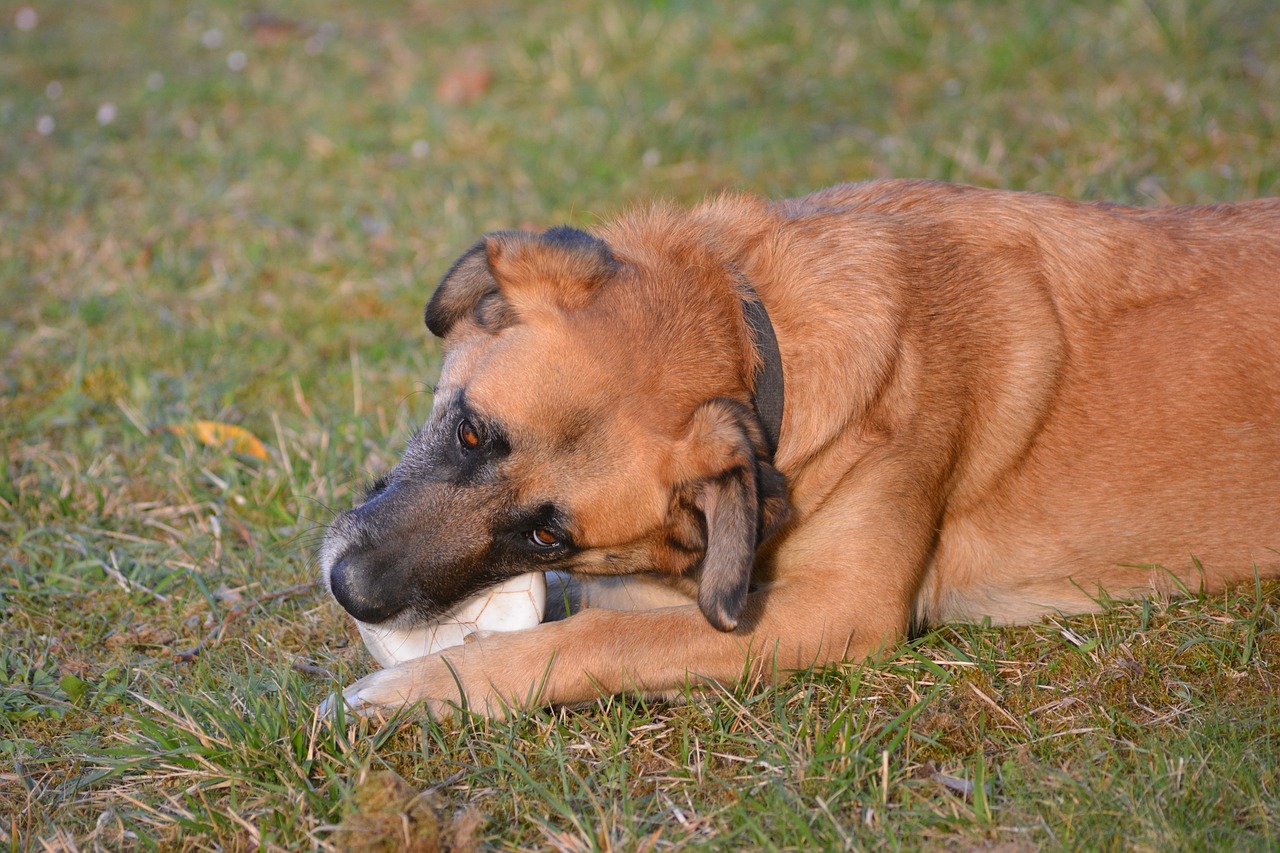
[321,222,787,630]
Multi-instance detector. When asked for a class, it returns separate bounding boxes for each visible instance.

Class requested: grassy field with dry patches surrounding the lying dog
[0,0,1280,850]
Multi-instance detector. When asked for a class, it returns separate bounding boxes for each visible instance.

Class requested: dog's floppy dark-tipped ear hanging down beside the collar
[680,398,790,631]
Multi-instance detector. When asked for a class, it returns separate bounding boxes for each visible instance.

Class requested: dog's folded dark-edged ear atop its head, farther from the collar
[426,225,617,338]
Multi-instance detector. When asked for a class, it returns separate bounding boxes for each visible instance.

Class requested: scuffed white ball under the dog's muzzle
[356,571,547,667]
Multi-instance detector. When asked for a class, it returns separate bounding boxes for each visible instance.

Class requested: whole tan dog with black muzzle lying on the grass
[321,182,1280,713]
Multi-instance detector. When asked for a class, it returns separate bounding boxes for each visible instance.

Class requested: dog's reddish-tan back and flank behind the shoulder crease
[827,183,1280,621]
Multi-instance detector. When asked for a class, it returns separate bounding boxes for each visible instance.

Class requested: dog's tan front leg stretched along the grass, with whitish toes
[330,455,936,716]
